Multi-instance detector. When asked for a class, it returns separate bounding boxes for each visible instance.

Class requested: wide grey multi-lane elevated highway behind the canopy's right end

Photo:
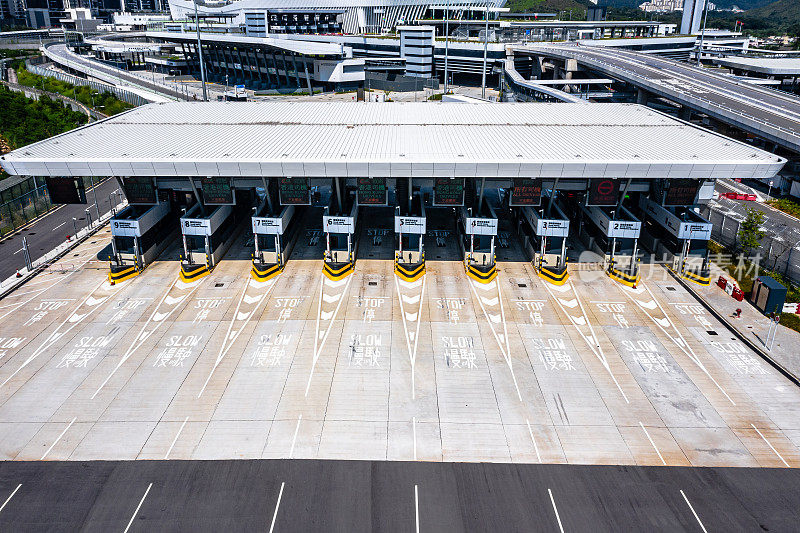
[509,44,800,153]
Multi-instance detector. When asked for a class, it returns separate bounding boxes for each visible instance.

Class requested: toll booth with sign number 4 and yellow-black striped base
[458,203,497,283]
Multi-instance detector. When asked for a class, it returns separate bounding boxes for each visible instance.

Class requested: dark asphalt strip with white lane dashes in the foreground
[0,460,800,532]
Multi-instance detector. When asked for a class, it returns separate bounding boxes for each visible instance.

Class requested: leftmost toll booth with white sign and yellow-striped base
[108,202,176,283]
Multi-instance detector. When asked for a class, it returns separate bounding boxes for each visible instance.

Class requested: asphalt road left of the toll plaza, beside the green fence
[0,179,119,280]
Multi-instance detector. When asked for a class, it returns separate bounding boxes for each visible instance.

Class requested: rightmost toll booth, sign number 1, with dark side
[639,196,712,285]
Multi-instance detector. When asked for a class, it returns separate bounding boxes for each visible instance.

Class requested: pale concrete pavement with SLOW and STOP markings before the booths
[0,209,800,467]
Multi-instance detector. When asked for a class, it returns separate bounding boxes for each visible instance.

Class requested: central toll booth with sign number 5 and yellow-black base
[394,194,427,281]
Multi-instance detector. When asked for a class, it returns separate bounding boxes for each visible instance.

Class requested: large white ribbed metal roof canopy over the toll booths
[0,102,786,179]
